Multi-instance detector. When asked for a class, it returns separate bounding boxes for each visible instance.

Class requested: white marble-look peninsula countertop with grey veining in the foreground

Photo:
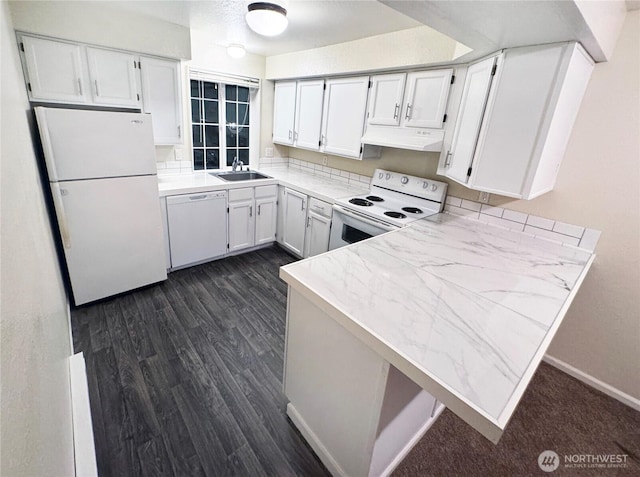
[280,214,594,442]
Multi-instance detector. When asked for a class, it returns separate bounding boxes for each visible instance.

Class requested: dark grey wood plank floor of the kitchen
[71,247,329,477]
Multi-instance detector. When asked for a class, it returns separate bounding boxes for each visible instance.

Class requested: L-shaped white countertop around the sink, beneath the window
[158,167,368,203]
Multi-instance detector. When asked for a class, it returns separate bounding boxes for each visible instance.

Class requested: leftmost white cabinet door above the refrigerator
[22,36,87,103]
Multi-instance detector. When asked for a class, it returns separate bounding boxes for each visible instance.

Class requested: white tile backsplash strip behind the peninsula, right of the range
[444,196,600,252]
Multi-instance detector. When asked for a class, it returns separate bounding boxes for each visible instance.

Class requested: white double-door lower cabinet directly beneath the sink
[229,185,278,252]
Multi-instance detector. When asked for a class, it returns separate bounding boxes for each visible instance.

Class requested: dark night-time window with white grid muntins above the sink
[191,79,250,170]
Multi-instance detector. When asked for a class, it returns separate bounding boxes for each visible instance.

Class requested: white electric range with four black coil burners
[329,169,447,250]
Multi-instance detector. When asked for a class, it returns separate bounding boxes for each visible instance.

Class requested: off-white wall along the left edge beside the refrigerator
[0,2,74,476]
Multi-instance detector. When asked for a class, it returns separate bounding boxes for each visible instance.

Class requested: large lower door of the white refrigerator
[52,176,167,305]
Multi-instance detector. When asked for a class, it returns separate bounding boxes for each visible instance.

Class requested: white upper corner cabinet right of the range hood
[438,43,594,199]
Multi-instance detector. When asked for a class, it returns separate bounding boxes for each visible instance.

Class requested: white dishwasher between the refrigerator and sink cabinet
[167,191,227,269]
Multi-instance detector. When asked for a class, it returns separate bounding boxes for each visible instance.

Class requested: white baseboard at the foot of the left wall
[69,353,98,477]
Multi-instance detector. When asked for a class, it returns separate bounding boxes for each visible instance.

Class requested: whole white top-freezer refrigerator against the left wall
[35,107,167,305]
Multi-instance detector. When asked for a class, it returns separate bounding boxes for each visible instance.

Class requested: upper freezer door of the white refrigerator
[35,106,157,182]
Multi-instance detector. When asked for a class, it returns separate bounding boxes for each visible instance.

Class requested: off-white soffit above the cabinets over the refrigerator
[9,1,191,59]
